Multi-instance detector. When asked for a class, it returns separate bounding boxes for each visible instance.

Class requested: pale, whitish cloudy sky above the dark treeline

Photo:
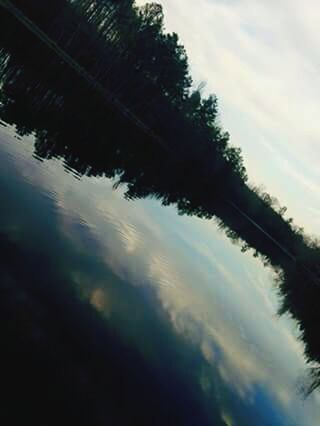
[137,0,320,237]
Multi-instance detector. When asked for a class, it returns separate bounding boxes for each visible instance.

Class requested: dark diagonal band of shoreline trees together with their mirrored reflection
[0,0,320,396]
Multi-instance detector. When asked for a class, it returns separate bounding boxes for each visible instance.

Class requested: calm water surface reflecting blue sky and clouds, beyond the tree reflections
[0,121,320,426]
